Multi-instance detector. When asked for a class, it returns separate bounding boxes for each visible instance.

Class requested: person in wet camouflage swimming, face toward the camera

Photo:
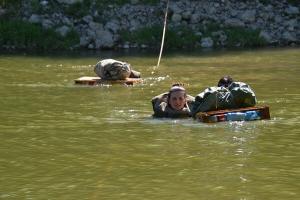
[151,83,194,118]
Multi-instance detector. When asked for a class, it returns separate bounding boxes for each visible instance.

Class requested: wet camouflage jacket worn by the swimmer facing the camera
[151,92,195,118]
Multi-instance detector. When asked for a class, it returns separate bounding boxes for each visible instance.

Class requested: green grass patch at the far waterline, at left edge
[0,20,79,50]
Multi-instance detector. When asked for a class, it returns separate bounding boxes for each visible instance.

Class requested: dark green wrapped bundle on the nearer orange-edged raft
[191,82,257,116]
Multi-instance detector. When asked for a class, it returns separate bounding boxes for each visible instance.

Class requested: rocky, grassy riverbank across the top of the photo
[0,0,300,50]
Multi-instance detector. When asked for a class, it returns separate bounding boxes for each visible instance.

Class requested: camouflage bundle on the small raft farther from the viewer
[94,59,131,80]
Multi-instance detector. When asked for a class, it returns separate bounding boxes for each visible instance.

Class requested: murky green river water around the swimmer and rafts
[0,49,300,200]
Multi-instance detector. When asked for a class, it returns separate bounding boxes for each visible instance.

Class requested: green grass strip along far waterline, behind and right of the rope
[121,23,266,49]
